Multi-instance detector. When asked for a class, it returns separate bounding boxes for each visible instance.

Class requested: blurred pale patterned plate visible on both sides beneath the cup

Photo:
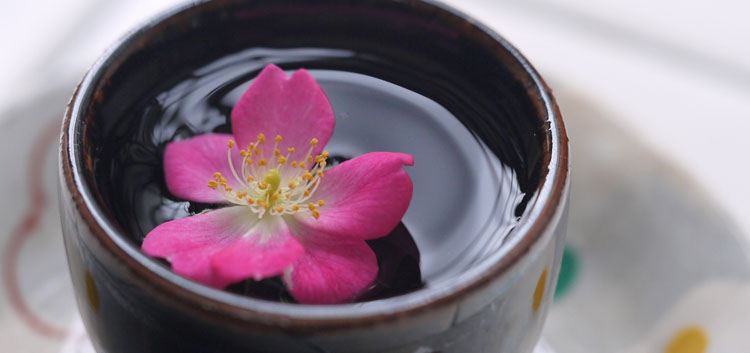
[0,88,750,353]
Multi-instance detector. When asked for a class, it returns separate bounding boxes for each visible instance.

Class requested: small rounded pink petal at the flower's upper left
[164,134,247,203]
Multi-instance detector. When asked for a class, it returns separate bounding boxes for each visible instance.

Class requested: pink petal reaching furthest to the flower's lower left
[141,206,258,288]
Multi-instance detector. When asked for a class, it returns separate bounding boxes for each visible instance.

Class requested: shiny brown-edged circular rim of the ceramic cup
[60,0,569,332]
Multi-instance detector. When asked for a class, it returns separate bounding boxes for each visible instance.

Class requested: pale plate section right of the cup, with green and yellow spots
[543,90,750,353]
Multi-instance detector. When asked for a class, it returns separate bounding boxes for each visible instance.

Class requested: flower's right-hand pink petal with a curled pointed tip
[297,152,414,239]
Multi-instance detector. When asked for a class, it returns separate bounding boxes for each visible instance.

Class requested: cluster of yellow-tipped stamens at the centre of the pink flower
[208,134,328,219]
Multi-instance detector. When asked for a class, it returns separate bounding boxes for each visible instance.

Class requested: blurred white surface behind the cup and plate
[0,0,750,234]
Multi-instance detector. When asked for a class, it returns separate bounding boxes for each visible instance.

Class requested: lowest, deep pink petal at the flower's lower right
[283,225,378,304]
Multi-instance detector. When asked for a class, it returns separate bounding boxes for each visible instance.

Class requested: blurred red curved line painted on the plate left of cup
[3,121,67,339]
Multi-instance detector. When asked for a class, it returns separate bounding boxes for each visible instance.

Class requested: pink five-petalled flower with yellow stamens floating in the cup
[142,65,414,304]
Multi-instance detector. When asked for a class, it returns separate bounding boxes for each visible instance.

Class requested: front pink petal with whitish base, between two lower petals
[212,216,304,282]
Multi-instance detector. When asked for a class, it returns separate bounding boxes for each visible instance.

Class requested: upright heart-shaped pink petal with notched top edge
[232,64,336,160]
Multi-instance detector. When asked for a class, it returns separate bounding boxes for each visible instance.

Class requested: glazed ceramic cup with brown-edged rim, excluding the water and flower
[60,0,569,353]
